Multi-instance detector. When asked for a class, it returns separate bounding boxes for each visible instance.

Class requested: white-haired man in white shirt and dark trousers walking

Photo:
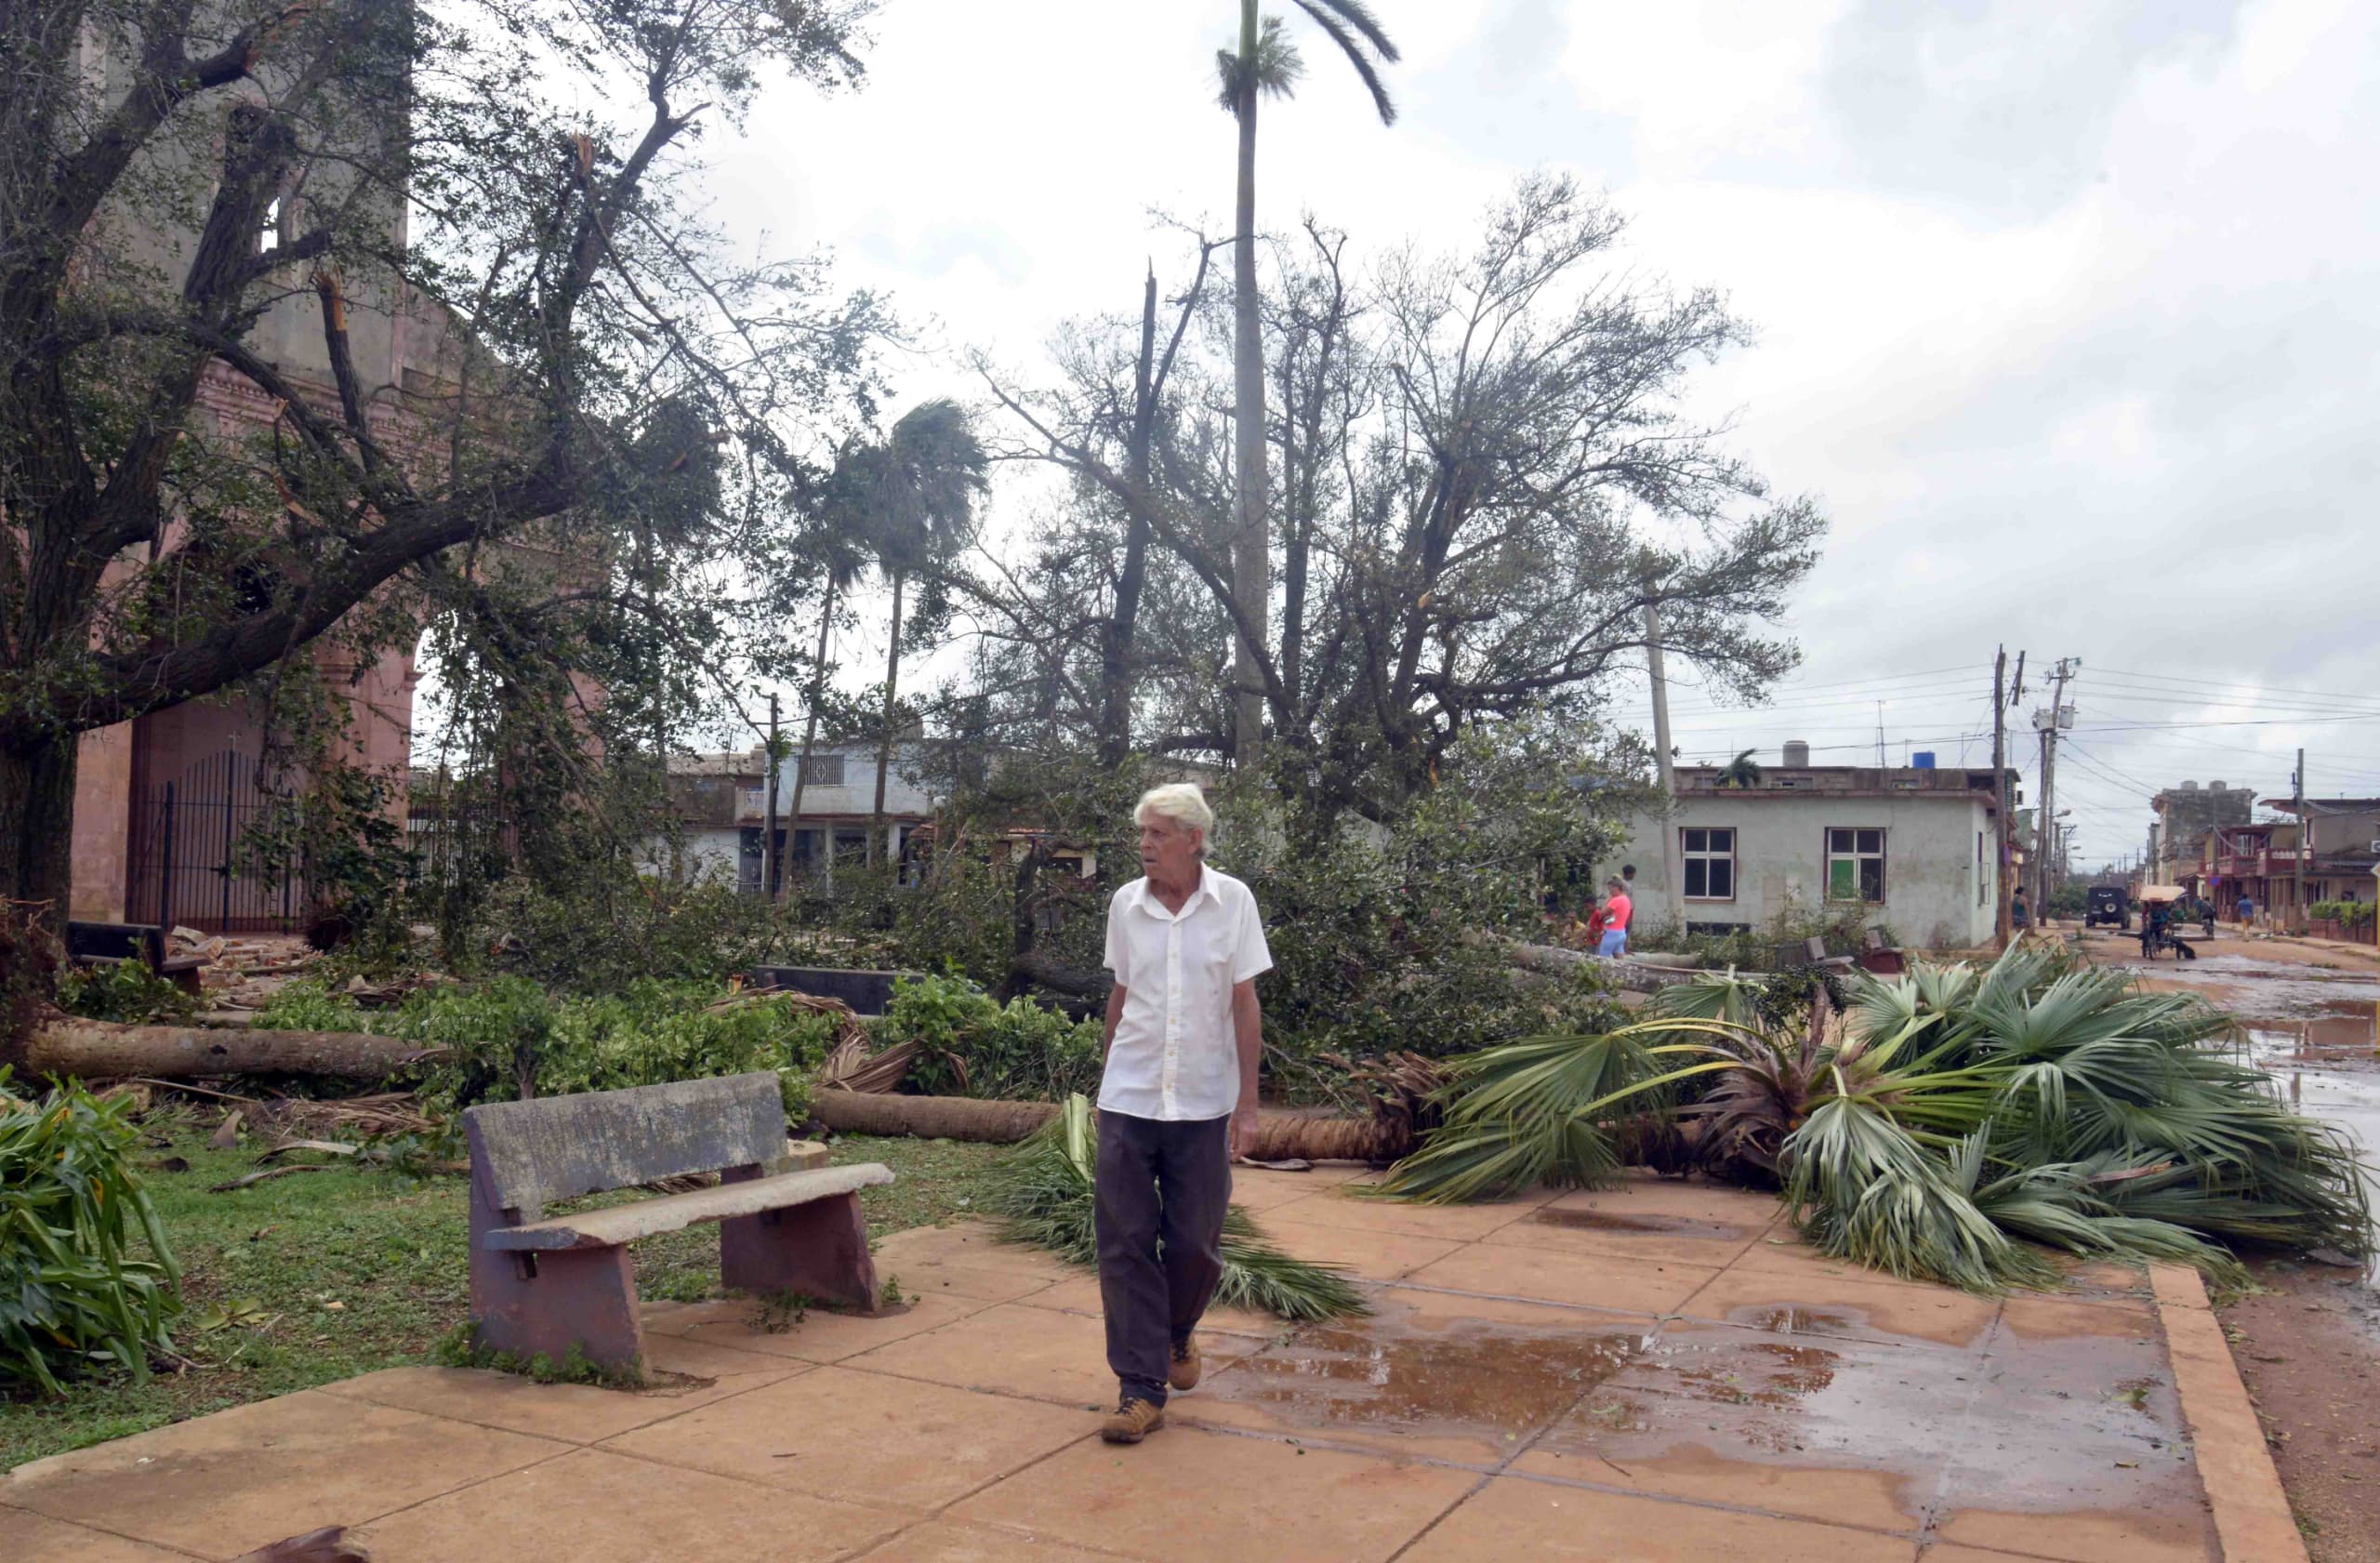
[1095,785,1274,1444]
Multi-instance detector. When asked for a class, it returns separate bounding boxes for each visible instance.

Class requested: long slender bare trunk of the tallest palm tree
[1231,0,1271,766]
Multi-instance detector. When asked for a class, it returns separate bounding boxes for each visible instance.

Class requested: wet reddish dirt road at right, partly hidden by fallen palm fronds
[2085,933,2380,1563]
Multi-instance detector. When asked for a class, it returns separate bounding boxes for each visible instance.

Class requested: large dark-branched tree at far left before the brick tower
[0,0,880,904]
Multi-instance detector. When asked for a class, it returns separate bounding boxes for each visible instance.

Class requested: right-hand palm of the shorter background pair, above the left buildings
[868,397,990,864]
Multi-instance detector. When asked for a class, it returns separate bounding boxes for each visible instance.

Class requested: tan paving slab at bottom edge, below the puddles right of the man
[1402,1477,1916,1563]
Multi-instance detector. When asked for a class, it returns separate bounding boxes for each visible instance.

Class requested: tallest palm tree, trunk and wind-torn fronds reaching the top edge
[1214,0,1397,763]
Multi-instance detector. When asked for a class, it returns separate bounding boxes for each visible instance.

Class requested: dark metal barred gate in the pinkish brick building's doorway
[124,749,307,933]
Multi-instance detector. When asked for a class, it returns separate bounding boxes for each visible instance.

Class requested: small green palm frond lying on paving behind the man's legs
[985,1094,1371,1320]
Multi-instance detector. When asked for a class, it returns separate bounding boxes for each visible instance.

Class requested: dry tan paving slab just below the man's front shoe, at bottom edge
[947,1425,1465,1563]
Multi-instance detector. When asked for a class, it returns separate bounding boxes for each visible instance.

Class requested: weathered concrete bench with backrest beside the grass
[462,1073,892,1371]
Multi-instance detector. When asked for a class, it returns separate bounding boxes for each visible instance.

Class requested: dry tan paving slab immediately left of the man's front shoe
[604,1368,1097,1511]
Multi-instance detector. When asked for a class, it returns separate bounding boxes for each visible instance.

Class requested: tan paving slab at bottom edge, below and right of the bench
[352,1449,917,1563]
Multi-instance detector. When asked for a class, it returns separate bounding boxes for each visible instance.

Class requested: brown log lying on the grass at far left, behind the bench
[24,1021,441,1080]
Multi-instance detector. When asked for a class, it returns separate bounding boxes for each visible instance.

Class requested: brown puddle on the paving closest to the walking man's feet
[1199,1304,1645,1449]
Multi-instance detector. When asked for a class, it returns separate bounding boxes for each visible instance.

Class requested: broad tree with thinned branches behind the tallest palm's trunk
[973,176,1823,823]
